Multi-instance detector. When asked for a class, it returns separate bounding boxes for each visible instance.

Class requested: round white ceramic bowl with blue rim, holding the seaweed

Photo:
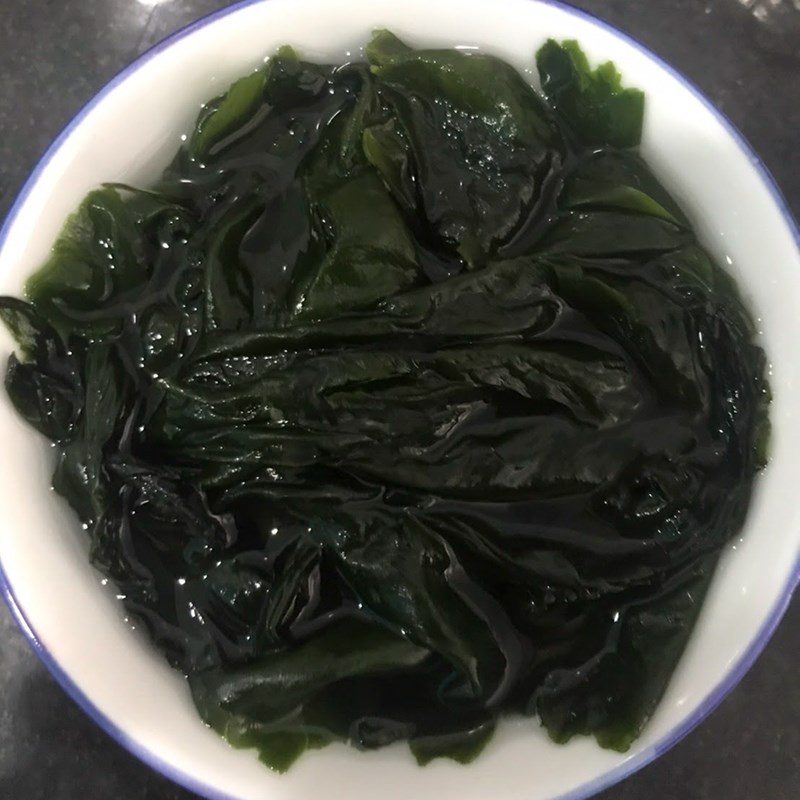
[0,0,800,800]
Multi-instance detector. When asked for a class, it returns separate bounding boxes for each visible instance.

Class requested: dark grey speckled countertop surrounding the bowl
[0,0,800,800]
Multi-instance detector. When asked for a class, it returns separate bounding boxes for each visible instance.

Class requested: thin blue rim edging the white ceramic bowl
[0,0,800,800]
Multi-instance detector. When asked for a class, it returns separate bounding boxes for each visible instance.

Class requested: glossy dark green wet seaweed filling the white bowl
[0,31,768,770]
